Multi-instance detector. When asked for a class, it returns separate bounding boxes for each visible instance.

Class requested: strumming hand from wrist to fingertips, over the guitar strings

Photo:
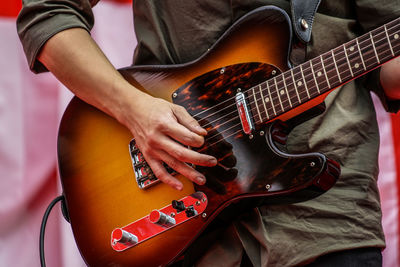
[122,95,217,190]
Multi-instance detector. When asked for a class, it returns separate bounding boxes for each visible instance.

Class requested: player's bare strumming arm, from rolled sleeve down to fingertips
[38,28,217,190]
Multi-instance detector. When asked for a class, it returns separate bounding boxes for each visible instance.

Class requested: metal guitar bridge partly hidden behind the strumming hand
[129,139,177,189]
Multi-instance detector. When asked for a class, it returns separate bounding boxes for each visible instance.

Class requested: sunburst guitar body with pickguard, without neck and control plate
[58,7,338,266]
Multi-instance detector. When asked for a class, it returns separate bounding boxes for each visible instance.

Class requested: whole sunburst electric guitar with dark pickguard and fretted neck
[58,7,400,266]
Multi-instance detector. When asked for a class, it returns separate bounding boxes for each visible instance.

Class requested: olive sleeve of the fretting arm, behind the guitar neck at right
[355,0,400,113]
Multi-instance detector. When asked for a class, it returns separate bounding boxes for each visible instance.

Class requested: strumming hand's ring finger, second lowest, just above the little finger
[159,152,206,185]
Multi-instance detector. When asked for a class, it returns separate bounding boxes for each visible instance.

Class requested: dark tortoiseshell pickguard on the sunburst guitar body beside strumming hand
[173,63,325,220]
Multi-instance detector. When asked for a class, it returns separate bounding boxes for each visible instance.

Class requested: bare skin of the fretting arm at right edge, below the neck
[380,57,400,100]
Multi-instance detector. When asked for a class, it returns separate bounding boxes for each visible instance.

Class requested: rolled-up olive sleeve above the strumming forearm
[17,0,98,73]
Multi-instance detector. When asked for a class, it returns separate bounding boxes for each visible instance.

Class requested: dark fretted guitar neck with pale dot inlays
[247,18,400,125]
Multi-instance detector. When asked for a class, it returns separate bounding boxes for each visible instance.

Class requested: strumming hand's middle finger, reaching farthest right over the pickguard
[160,138,217,167]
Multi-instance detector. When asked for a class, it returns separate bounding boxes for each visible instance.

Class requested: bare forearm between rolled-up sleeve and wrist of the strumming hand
[38,28,145,126]
